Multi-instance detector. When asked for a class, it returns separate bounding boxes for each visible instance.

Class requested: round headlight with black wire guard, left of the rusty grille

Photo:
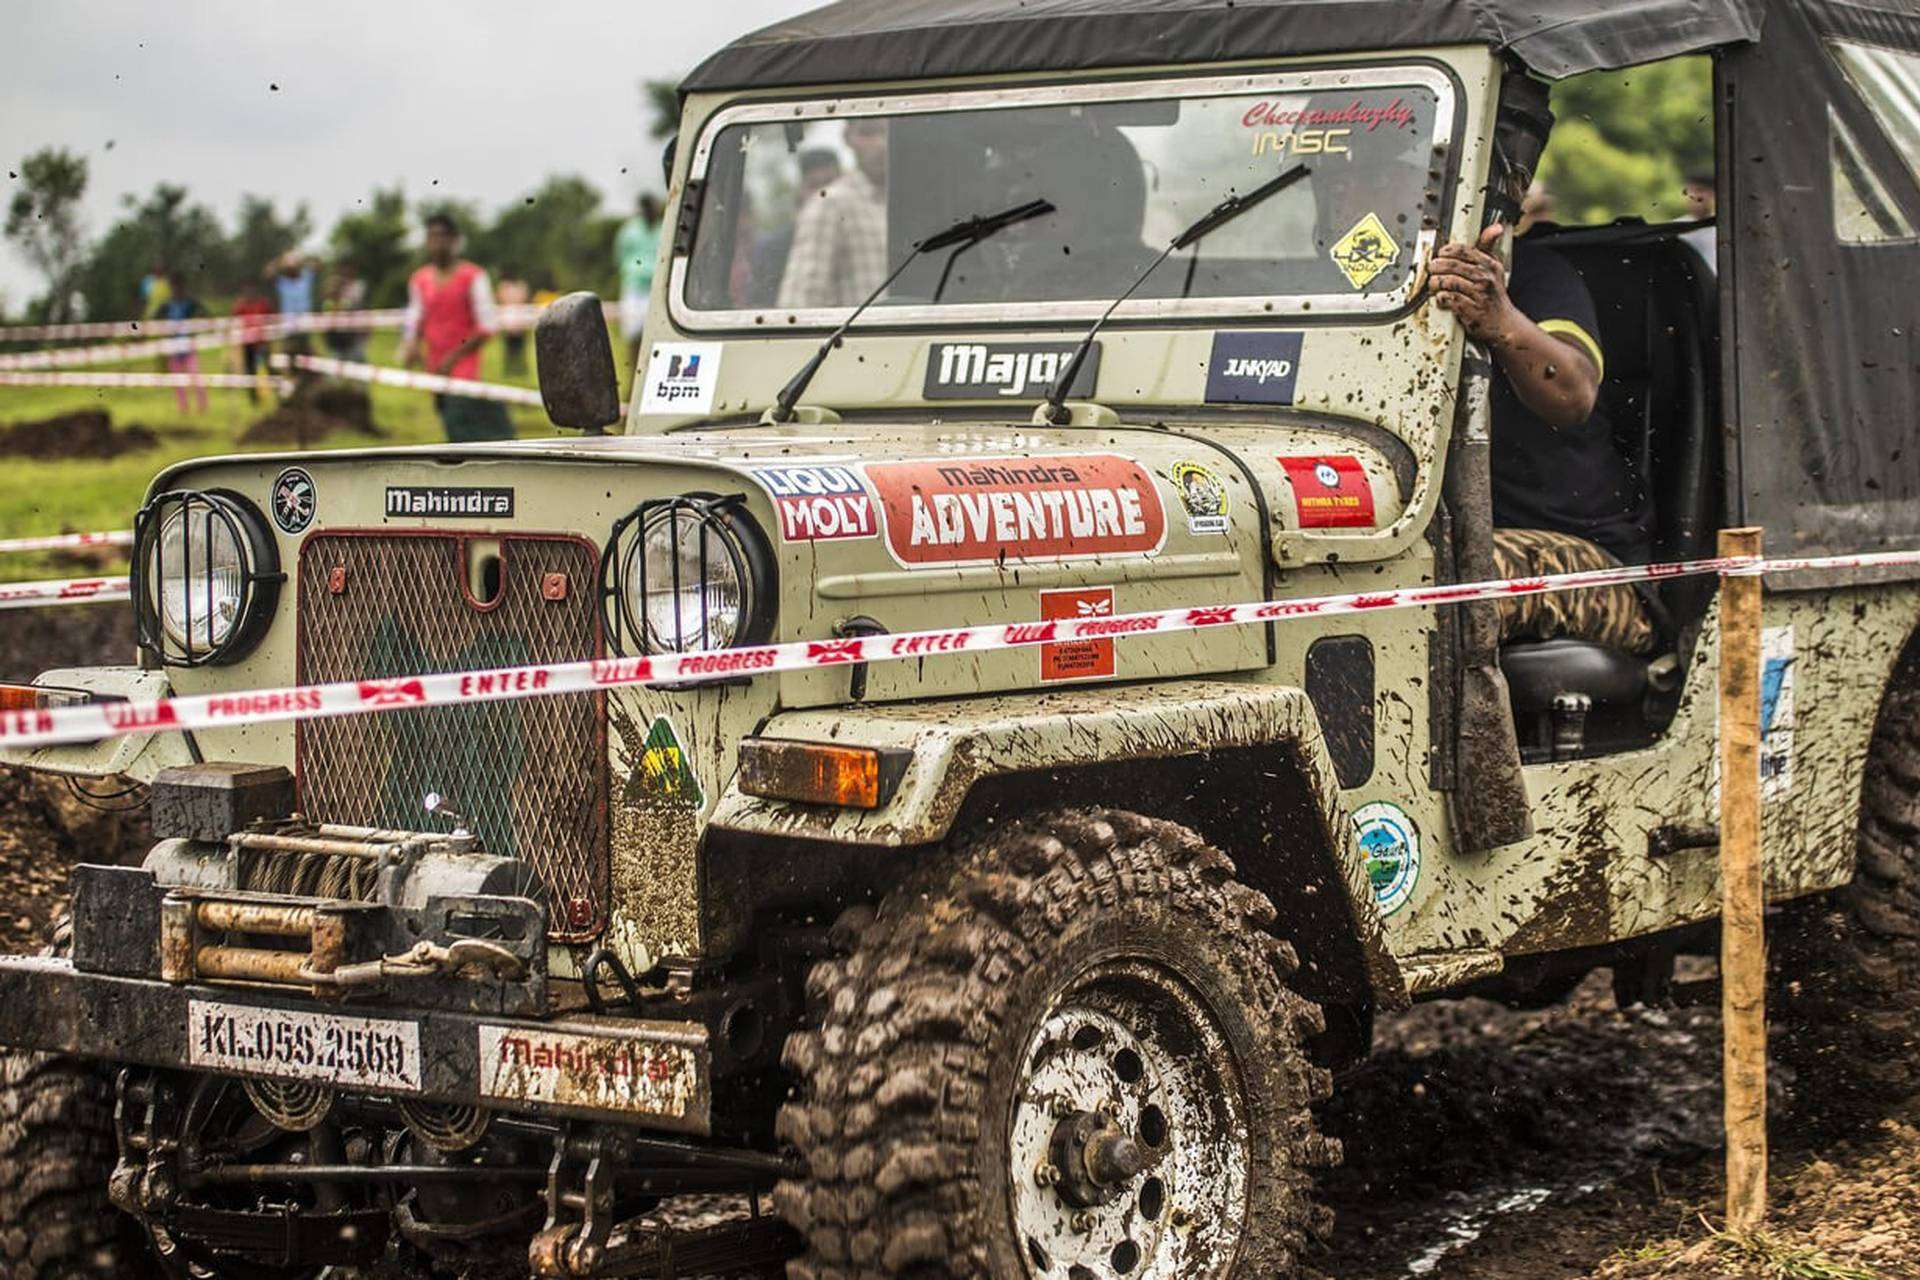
[132,489,286,666]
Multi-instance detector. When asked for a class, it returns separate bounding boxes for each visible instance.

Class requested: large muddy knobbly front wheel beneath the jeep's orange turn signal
[776,810,1338,1280]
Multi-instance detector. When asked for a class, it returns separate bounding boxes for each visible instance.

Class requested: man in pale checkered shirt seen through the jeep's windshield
[780,117,889,309]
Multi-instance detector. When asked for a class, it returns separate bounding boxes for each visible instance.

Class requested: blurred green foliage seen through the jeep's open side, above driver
[1540,58,1713,223]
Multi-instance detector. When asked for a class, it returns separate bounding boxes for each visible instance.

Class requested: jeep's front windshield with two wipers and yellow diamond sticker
[674,67,1453,328]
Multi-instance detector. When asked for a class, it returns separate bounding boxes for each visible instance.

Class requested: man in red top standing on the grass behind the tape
[399,213,513,443]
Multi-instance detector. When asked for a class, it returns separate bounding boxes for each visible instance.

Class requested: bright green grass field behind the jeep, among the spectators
[0,332,576,581]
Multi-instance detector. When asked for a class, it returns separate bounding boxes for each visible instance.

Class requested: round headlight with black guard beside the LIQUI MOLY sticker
[599,493,776,656]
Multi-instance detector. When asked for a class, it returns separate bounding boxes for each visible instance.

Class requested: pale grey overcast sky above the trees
[0,0,820,311]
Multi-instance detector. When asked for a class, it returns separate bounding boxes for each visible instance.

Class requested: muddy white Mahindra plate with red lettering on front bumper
[480,1025,701,1119]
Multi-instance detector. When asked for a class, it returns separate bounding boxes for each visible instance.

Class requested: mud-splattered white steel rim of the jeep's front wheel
[1008,960,1252,1280]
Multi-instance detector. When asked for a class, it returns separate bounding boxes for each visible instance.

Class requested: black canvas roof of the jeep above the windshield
[682,0,1766,92]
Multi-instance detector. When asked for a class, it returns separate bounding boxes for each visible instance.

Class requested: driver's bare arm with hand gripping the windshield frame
[1427,223,1605,428]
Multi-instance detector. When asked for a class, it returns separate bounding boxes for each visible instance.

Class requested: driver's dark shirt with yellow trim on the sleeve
[1492,240,1653,564]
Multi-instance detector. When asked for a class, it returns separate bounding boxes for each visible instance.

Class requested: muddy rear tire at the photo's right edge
[1776,689,1920,1096]
